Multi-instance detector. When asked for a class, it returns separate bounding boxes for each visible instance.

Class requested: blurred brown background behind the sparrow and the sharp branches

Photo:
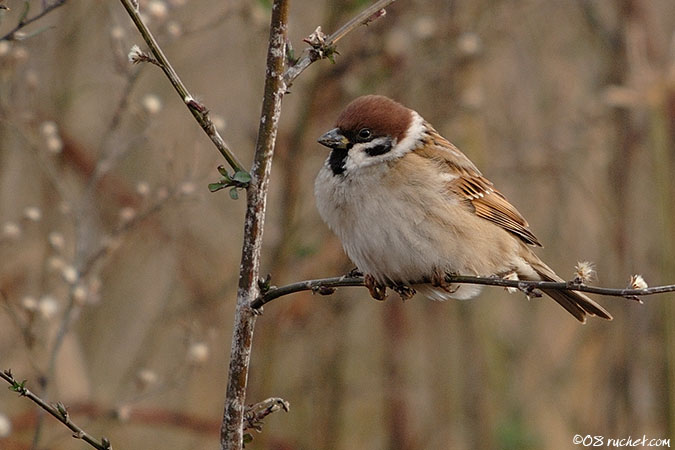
[0,0,675,450]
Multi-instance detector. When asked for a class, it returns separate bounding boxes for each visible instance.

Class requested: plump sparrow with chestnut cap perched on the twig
[314,95,612,322]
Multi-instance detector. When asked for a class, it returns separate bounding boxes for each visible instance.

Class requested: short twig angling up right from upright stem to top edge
[284,0,396,88]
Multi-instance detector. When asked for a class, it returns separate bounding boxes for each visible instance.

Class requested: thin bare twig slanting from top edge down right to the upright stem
[120,0,245,172]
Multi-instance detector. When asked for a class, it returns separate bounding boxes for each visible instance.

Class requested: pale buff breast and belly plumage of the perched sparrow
[315,165,516,299]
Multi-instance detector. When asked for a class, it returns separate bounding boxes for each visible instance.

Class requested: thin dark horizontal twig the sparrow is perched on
[251,275,675,309]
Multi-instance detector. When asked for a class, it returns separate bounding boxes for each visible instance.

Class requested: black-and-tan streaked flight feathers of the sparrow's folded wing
[450,173,541,247]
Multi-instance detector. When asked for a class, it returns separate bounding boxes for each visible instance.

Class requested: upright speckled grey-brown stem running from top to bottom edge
[220,0,288,450]
